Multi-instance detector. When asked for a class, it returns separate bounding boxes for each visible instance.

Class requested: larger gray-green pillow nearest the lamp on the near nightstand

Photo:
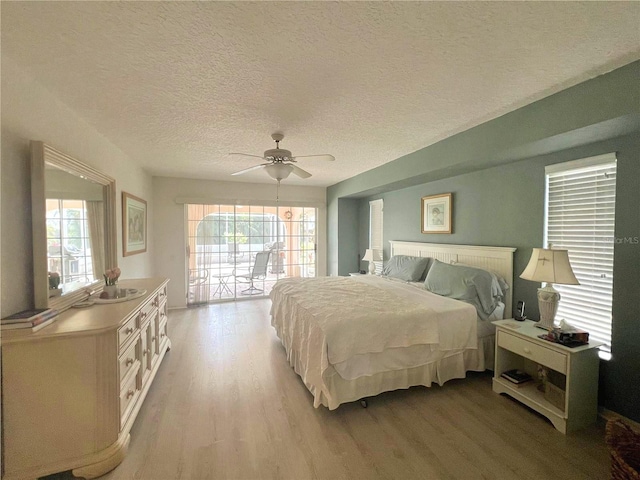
[424,260,503,319]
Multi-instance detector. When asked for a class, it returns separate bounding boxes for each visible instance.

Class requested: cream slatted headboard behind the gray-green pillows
[389,240,516,318]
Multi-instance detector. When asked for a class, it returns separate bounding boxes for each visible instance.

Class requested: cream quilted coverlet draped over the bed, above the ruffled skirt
[271,276,477,406]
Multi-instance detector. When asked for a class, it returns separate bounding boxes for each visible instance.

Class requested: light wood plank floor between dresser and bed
[46,300,609,480]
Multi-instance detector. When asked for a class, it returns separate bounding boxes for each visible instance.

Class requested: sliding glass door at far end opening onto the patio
[187,204,317,305]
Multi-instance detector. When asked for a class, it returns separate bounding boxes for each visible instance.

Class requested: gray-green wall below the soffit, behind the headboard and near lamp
[358,135,640,421]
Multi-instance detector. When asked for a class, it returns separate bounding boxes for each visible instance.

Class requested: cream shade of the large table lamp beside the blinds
[520,248,580,285]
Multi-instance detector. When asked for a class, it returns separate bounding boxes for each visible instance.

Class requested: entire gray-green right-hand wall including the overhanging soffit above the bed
[327,62,640,421]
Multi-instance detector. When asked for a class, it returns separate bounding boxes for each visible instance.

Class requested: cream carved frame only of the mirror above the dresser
[31,141,118,312]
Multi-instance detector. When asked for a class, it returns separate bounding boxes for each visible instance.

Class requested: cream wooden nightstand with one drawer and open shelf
[492,320,602,433]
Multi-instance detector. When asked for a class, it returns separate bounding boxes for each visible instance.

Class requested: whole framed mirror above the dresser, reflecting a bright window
[31,142,117,311]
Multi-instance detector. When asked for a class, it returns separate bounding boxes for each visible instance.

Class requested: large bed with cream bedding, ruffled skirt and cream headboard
[271,241,515,410]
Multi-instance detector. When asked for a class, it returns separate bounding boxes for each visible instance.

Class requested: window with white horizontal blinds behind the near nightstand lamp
[545,154,616,351]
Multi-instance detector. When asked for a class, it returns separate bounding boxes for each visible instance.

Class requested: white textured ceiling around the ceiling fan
[1,1,640,186]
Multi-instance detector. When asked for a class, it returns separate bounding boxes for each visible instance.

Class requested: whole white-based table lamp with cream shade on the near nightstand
[520,245,580,329]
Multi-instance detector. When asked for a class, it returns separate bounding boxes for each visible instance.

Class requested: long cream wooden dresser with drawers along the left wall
[2,278,171,479]
